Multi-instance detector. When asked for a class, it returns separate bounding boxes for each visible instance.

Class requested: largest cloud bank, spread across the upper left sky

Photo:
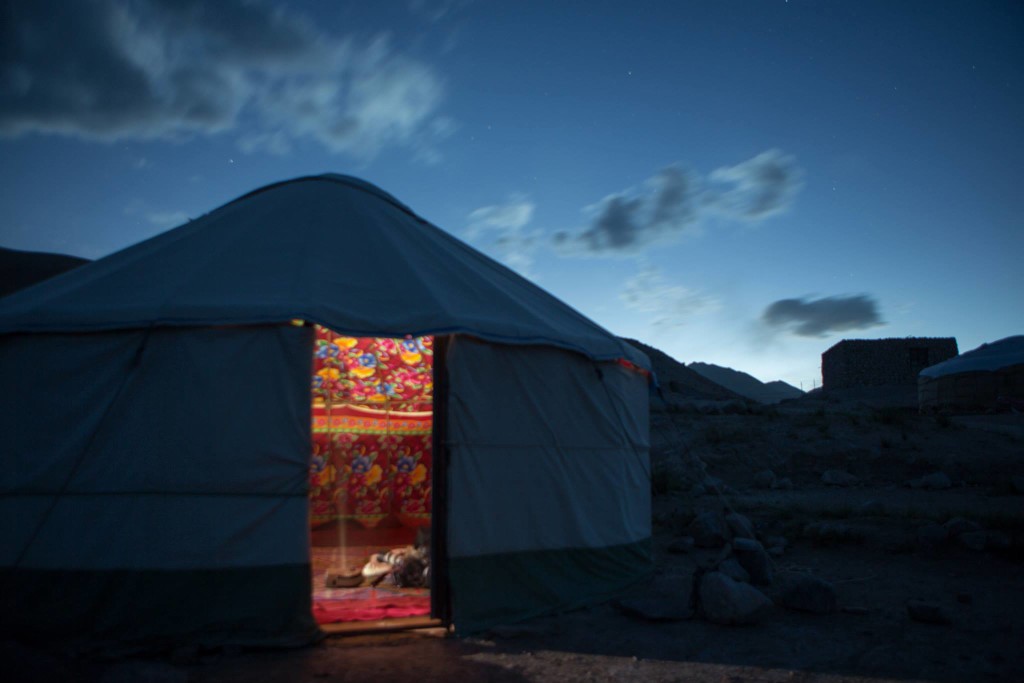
[0,0,443,157]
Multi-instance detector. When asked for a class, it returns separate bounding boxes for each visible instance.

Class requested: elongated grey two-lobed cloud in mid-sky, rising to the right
[552,150,802,256]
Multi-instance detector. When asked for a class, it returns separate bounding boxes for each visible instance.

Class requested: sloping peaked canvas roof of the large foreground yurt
[0,174,649,369]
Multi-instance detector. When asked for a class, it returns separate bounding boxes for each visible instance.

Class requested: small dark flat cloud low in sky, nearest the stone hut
[761,294,884,337]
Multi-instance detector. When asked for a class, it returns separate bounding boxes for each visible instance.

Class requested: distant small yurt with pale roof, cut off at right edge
[918,335,1024,413]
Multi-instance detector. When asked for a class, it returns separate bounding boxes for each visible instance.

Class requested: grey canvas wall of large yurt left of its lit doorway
[0,325,317,644]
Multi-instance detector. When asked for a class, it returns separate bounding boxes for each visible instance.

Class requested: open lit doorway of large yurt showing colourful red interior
[309,326,442,627]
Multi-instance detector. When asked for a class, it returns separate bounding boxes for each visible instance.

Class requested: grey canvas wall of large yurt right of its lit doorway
[447,338,652,632]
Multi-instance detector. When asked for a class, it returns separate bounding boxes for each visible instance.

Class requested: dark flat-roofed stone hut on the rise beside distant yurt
[821,337,958,391]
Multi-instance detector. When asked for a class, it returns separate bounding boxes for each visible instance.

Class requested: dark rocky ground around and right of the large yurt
[3,398,1024,683]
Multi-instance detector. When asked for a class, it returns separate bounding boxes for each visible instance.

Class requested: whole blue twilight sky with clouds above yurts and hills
[0,0,1024,389]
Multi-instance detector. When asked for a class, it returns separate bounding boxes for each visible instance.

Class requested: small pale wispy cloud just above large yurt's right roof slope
[466,195,538,276]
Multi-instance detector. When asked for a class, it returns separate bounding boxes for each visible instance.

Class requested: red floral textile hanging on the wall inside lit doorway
[310,327,433,527]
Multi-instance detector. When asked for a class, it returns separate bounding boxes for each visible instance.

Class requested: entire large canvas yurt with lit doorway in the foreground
[0,175,651,645]
